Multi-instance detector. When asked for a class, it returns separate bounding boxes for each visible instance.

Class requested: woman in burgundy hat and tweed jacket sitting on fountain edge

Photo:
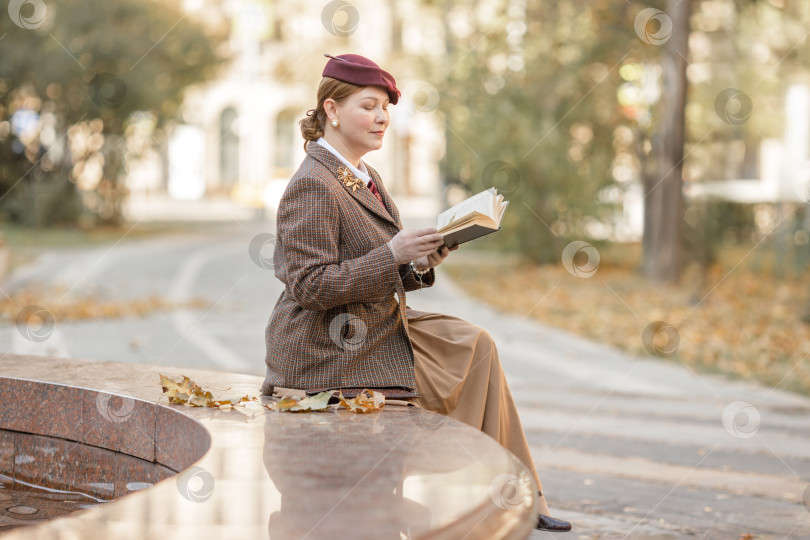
[262,54,571,531]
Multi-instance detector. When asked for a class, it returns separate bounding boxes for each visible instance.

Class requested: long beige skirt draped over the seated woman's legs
[408,312,543,491]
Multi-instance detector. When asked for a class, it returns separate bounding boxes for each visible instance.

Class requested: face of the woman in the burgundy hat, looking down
[326,86,388,158]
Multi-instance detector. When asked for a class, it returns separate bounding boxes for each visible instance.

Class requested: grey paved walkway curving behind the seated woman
[0,223,810,539]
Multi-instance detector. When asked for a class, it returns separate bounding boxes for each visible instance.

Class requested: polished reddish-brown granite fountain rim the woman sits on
[0,355,537,540]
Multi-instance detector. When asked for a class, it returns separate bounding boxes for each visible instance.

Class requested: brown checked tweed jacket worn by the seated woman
[262,142,436,393]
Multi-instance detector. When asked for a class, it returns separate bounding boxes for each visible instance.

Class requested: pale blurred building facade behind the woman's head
[124,0,444,219]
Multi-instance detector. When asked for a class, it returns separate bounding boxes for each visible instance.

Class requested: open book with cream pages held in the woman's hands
[436,187,509,247]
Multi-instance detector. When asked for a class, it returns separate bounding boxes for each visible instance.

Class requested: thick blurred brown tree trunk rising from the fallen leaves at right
[642,0,692,283]
